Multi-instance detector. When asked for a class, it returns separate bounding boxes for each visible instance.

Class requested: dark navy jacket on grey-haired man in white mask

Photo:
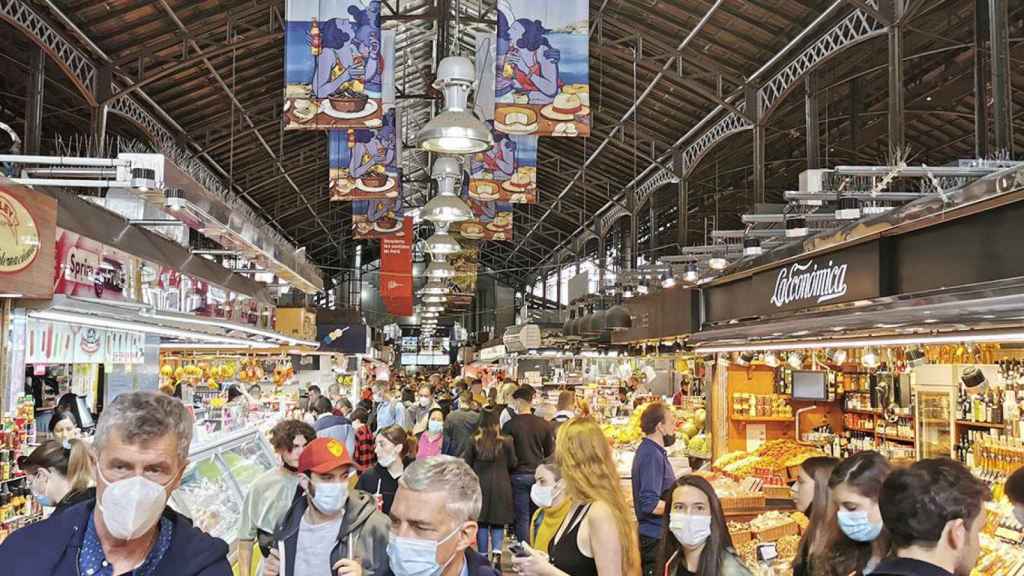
[0,499,231,576]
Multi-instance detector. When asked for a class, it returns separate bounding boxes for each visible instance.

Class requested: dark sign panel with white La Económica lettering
[751,242,881,315]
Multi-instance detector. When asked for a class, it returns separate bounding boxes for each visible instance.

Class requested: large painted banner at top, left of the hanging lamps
[285,0,384,130]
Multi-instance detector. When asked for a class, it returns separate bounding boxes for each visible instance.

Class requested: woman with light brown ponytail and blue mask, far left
[17,440,96,511]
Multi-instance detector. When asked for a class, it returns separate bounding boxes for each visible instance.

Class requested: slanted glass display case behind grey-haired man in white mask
[171,428,276,544]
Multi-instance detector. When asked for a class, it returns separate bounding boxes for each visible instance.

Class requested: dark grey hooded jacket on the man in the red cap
[274,488,391,576]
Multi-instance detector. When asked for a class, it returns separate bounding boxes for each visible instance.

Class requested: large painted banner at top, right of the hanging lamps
[495,0,591,137]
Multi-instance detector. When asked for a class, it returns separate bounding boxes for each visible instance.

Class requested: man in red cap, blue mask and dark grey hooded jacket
[263,438,390,576]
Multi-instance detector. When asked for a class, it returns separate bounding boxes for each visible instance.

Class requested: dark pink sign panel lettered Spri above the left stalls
[53,229,134,301]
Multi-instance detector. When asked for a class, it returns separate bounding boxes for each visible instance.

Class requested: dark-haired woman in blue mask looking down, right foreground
[814,452,891,576]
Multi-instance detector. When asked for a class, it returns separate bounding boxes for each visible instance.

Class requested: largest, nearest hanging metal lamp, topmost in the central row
[416,56,494,154]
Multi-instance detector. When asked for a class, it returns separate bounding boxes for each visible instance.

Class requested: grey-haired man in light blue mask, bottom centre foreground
[387,456,499,576]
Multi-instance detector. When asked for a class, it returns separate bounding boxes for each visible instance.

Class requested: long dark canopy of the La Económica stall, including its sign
[690,162,1024,351]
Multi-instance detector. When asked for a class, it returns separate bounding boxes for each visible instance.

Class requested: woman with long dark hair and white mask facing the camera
[654,476,751,576]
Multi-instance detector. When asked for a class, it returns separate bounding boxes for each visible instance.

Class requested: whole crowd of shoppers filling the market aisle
[0,378,1011,576]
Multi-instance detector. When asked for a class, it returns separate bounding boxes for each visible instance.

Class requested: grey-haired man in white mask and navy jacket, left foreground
[0,392,231,576]
